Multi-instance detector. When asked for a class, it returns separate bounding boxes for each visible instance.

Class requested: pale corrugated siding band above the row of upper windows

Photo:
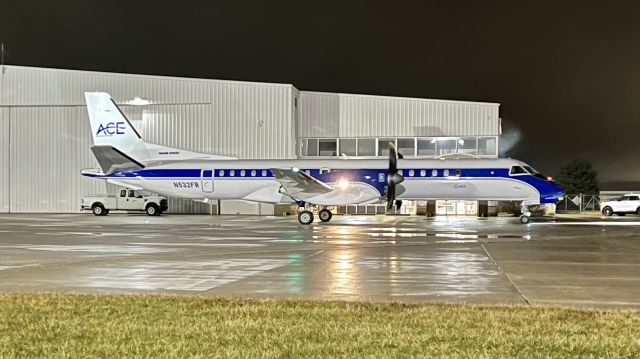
[298,91,500,137]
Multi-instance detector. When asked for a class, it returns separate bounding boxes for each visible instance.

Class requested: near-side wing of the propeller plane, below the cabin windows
[271,168,333,199]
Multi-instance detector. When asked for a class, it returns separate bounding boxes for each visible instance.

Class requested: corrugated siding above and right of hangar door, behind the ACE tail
[0,66,295,158]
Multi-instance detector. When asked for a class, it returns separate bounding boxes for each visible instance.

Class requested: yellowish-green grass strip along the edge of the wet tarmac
[0,293,640,358]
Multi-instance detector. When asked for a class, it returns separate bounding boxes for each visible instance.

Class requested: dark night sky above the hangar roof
[0,0,640,181]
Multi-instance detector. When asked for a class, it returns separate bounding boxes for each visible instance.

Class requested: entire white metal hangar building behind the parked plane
[0,66,501,215]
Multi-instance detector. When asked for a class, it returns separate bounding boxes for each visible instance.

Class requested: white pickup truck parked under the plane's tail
[81,189,169,216]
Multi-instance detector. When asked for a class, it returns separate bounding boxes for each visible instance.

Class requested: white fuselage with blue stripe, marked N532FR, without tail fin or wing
[87,159,557,206]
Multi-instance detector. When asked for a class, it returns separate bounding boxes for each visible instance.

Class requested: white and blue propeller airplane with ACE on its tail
[81,92,564,225]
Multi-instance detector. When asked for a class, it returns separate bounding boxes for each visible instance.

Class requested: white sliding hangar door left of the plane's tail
[10,106,106,212]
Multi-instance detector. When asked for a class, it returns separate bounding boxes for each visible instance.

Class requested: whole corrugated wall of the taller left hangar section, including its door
[0,66,295,213]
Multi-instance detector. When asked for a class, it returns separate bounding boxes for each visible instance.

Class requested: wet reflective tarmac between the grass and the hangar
[0,214,640,308]
